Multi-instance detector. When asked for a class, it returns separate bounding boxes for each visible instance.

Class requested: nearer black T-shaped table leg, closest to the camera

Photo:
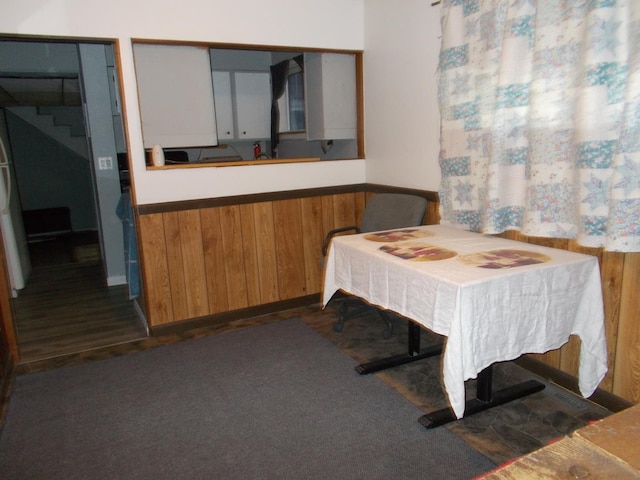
[418,366,544,428]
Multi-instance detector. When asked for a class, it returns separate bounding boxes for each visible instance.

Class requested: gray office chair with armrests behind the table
[322,193,427,338]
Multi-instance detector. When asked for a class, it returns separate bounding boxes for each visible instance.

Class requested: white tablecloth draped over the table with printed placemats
[323,225,607,418]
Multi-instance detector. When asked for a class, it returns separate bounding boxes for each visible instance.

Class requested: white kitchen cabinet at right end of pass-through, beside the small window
[304,52,357,140]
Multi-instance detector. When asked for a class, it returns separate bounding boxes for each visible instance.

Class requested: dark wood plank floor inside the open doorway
[12,236,147,364]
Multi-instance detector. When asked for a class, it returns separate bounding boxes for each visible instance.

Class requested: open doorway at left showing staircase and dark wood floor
[0,38,146,363]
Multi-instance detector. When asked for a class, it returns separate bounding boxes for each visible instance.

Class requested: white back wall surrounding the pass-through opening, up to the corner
[0,0,365,204]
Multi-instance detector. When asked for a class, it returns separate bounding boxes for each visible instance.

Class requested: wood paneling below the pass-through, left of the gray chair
[138,192,365,328]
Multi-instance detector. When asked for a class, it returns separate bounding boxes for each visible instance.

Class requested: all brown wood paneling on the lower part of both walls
[138,186,640,403]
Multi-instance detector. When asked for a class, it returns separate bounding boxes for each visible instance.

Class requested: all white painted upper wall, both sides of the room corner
[0,0,439,204]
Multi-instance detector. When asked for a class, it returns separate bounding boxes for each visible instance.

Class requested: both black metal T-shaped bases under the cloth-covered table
[355,321,545,428]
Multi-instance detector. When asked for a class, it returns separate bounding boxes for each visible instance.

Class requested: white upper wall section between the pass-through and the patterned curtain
[364,0,441,191]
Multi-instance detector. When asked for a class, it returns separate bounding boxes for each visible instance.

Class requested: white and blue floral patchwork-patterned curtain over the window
[438,0,640,252]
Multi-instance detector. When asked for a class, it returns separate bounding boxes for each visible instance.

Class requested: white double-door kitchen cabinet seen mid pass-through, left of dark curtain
[212,71,271,140]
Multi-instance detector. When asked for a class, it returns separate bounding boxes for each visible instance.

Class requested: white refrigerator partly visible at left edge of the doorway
[0,110,31,297]
